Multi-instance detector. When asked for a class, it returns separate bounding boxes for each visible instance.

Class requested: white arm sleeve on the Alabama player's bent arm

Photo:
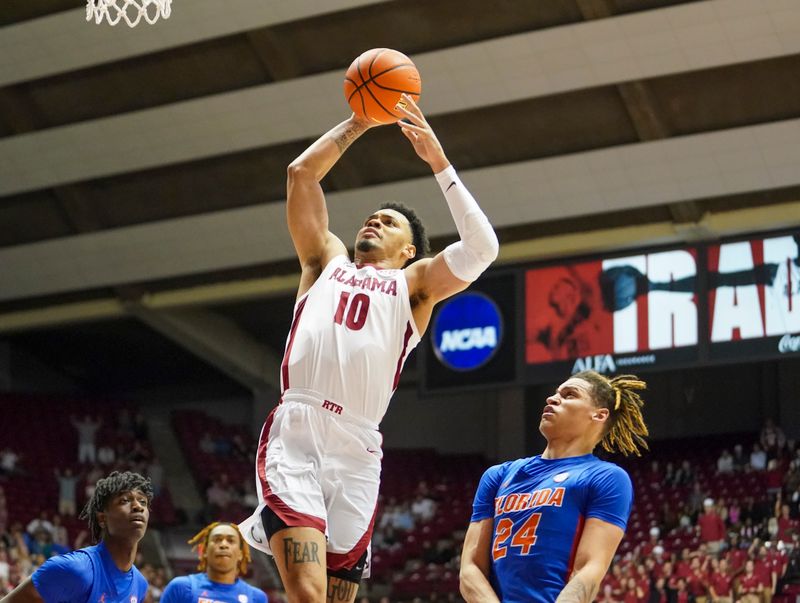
[436,165,500,283]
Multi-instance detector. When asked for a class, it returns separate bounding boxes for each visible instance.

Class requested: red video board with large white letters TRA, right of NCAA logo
[522,232,800,383]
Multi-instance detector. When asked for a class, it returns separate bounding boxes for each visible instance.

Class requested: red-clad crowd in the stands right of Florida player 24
[597,421,800,603]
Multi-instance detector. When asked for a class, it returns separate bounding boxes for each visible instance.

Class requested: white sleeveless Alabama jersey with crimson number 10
[281,255,420,425]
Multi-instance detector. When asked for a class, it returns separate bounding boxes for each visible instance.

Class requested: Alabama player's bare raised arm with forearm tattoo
[286,115,373,272]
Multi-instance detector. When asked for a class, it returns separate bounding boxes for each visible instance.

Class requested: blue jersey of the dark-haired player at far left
[32,542,147,603]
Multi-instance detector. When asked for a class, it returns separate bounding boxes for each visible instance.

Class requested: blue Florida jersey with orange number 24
[472,454,633,603]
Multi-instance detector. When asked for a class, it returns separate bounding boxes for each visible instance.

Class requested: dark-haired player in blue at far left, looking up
[2,471,153,603]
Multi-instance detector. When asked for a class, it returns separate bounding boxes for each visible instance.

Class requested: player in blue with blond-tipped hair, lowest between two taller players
[161,522,267,603]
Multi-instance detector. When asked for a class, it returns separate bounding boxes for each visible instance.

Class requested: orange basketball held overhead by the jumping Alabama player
[344,48,422,124]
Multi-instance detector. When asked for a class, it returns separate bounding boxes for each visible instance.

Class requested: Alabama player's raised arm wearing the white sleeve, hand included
[398,94,499,306]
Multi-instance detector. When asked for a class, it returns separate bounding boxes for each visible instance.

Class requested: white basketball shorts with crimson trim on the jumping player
[240,390,383,577]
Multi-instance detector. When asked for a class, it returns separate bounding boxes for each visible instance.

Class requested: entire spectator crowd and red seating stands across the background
[0,398,800,603]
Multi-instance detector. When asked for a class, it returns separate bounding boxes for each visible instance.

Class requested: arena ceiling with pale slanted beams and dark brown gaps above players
[0,0,800,389]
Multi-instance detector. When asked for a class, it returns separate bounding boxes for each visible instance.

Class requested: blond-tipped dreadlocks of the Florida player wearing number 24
[573,371,649,456]
